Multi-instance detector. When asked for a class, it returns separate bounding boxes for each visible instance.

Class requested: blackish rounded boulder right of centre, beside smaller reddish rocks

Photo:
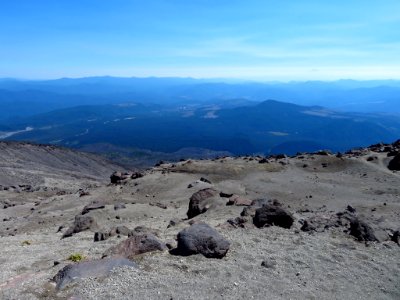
[253,204,294,228]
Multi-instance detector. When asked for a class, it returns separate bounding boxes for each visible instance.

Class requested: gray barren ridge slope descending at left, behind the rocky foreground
[0,142,122,188]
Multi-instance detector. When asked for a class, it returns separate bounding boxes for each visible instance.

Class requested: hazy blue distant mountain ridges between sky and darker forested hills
[0,76,400,120]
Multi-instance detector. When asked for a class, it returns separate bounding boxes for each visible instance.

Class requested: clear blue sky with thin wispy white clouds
[0,0,400,81]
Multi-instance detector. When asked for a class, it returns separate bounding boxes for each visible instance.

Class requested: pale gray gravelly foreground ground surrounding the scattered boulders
[0,144,400,299]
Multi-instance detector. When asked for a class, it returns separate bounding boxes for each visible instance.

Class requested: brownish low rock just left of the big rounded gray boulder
[103,233,167,258]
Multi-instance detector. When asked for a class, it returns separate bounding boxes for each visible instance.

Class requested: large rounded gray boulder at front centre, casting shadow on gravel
[173,223,230,258]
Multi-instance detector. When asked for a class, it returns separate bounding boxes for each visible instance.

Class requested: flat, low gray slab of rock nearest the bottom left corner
[52,258,137,290]
